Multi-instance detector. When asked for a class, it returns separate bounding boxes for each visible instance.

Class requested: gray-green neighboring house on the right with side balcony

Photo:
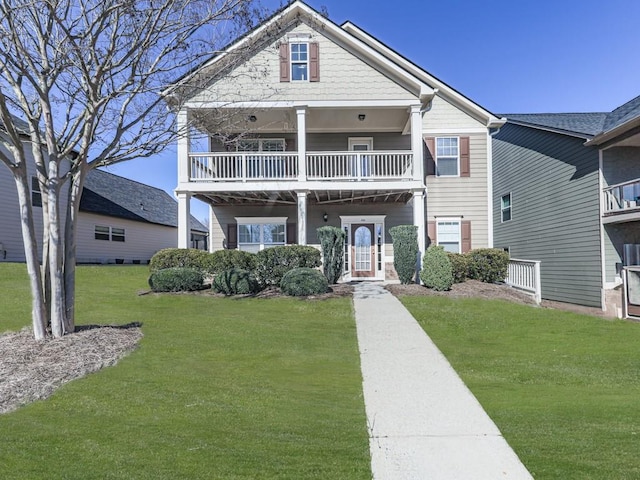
[493,97,640,316]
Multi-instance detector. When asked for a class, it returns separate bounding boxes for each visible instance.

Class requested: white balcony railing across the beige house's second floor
[189,151,413,182]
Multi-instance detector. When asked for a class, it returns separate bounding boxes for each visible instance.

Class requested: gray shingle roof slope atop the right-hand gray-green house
[503,112,608,137]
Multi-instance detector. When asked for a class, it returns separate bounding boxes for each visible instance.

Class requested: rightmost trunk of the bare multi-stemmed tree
[64,165,86,332]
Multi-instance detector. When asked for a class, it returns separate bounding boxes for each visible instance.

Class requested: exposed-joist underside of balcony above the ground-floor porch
[195,190,413,206]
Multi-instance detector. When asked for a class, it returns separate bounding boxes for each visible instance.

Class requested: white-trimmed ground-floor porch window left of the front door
[236,217,287,253]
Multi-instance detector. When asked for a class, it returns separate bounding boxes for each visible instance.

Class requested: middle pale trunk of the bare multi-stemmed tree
[48,159,66,337]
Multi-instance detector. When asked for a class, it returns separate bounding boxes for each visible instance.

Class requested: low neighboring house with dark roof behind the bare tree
[0,151,207,263]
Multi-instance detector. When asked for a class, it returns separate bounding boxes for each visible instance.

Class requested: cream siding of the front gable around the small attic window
[193,24,417,102]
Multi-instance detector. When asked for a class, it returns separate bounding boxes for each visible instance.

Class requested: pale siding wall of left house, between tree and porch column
[76,212,178,263]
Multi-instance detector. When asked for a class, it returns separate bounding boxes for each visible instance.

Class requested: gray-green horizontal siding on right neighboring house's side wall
[493,124,602,307]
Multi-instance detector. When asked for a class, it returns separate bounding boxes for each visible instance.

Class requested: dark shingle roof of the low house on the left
[80,170,207,232]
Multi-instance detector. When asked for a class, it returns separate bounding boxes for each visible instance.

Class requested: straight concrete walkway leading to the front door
[354,283,533,480]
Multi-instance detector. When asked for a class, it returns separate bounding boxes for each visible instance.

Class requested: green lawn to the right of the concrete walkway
[402,297,640,480]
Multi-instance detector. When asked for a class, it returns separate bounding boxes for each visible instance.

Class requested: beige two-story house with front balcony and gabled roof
[165,1,504,280]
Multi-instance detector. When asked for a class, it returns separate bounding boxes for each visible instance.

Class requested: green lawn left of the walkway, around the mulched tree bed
[0,264,371,480]
